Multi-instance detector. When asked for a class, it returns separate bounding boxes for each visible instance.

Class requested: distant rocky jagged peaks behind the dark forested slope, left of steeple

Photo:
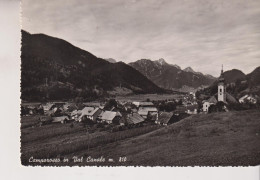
[129,59,215,89]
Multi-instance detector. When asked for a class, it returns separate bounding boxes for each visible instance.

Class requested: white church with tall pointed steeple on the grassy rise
[202,65,229,112]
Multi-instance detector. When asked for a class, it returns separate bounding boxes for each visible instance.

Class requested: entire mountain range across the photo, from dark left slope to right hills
[21,30,260,101]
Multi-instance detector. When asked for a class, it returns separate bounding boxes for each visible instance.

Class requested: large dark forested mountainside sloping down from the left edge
[21,31,164,100]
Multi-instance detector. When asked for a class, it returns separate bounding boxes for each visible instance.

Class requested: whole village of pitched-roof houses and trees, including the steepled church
[21,66,257,134]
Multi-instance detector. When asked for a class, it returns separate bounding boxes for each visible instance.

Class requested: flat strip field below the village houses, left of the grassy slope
[21,116,160,165]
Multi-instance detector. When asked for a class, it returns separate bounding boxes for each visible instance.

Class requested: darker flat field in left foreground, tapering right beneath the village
[21,121,159,165]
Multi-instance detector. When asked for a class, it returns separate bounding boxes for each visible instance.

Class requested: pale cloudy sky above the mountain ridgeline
[22,0,260,76]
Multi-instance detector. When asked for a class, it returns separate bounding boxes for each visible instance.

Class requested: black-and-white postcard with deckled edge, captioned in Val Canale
[20,0,260,166]
